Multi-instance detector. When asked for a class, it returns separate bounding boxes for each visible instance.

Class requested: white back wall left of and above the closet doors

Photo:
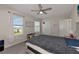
[42,16,69,36]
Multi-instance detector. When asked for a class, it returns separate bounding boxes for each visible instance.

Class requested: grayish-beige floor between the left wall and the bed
[2,42,29,54]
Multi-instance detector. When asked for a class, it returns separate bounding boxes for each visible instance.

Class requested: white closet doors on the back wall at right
[59,19,72,37]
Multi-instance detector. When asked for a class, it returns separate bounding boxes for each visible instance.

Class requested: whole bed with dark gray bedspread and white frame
[26,35,79,54]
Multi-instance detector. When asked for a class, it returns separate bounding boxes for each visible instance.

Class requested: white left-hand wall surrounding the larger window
[0,7,34,48]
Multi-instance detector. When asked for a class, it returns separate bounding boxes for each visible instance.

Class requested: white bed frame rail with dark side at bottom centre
[26,42,53,54]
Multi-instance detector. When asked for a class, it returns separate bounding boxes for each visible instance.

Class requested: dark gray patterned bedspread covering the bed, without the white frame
[27,35,79,54]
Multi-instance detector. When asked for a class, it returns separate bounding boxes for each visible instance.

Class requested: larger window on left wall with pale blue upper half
[12,15,23,35]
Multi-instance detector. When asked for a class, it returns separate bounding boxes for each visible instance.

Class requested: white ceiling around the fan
[1,4,74,18]
